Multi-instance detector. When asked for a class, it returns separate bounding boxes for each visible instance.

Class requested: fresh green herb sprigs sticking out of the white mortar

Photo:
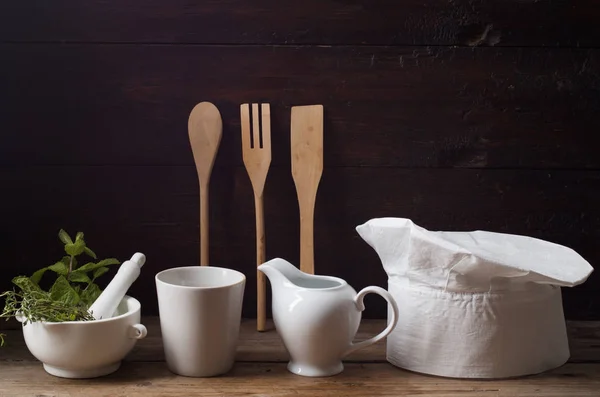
[0,229,120,332]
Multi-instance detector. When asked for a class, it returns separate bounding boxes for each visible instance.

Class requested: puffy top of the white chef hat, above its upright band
[356,218,593,292]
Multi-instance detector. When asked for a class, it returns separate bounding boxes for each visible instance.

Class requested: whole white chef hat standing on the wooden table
[356,218,593,378]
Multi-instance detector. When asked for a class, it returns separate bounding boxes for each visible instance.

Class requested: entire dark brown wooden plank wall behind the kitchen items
[0,0,600,319]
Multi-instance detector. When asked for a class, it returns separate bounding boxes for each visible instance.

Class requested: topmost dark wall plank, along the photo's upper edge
[0,0,600,47]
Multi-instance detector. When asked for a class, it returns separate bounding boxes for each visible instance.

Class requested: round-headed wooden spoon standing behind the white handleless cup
[188,102,223,266]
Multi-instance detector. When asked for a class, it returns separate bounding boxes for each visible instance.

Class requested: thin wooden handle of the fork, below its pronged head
[254,195,267,331]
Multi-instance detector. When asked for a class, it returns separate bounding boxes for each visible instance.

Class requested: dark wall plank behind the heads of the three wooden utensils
[0,44,600,169]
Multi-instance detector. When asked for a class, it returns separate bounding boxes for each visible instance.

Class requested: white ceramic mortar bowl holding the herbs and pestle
[23,296,147,378]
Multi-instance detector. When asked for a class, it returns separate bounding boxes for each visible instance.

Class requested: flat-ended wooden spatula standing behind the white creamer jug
[291,105,323,274]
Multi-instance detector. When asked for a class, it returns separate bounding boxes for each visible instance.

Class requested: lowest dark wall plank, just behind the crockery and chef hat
[0,166,600,319]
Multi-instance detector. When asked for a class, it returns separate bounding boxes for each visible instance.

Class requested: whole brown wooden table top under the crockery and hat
[0,317,600,397]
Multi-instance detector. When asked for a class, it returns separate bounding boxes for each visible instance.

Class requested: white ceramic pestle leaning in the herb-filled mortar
[89,252,146,320]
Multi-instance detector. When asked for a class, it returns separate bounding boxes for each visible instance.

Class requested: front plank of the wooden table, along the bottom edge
[0,362,600,397]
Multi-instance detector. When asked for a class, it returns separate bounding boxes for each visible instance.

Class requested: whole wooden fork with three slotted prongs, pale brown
[240,103,271,331]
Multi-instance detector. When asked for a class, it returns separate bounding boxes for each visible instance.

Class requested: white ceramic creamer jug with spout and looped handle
[258,258,398,376]
